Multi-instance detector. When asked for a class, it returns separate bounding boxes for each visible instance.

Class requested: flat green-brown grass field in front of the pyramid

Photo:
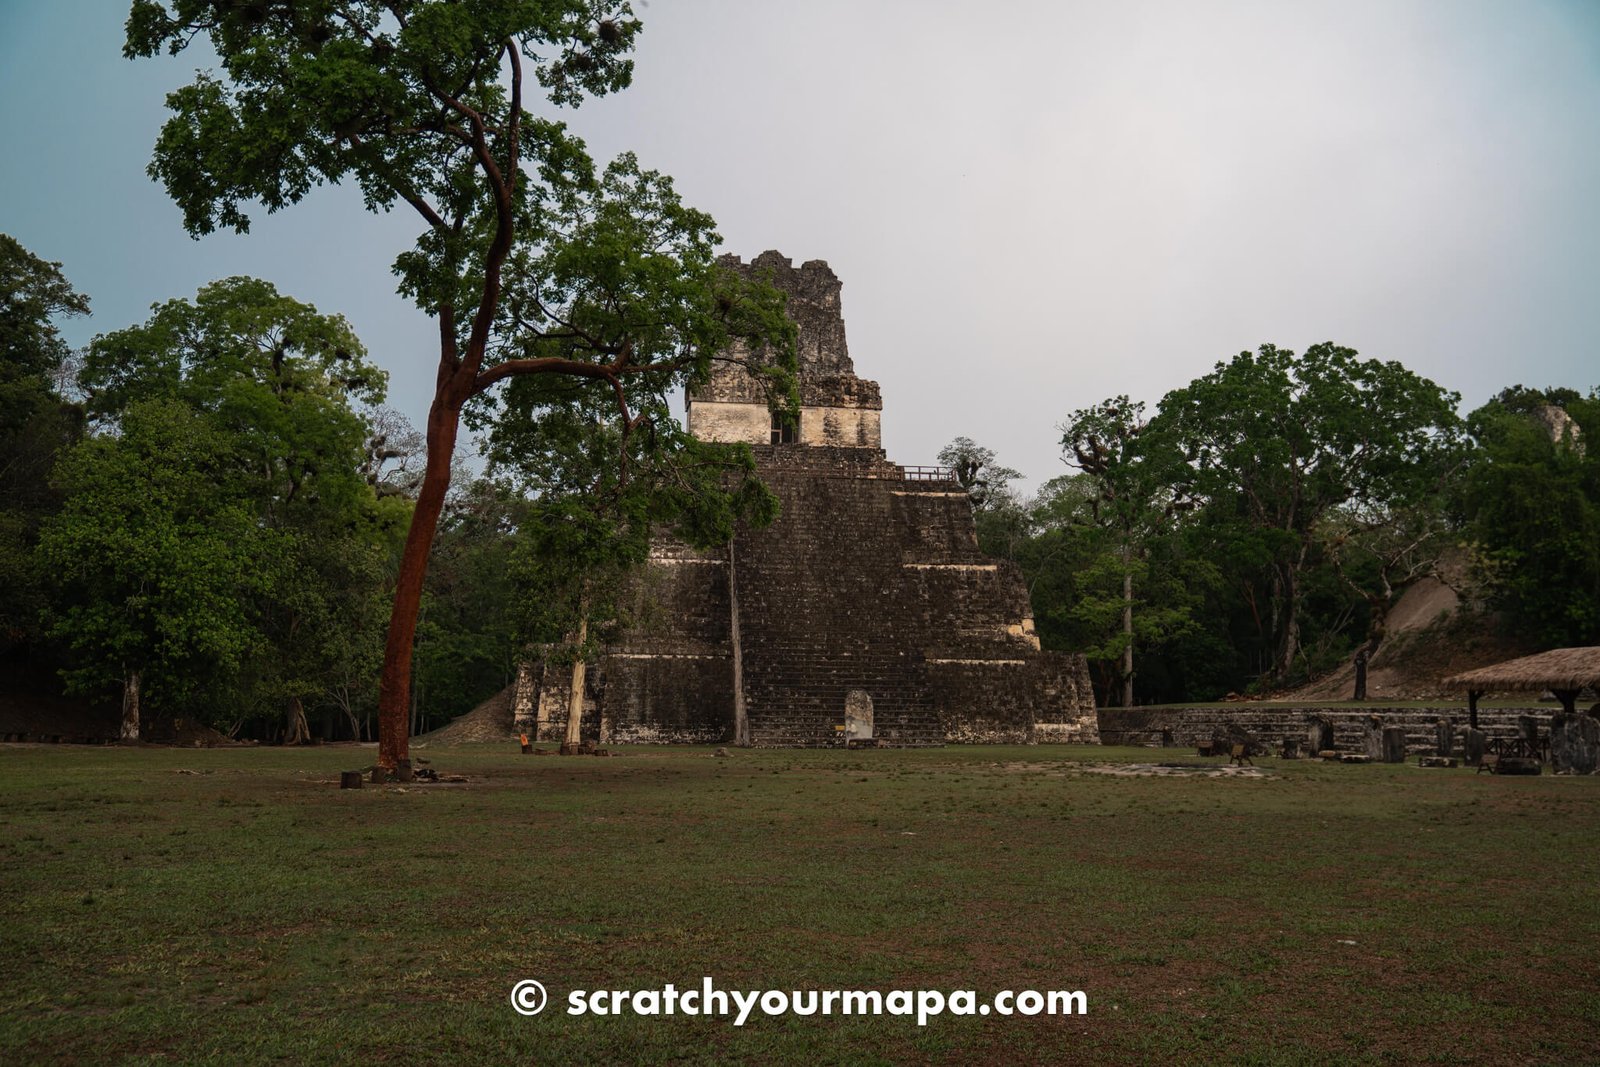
[0,745,1600,1064]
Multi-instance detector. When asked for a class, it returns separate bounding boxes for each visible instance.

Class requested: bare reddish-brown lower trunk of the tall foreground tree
[378,388,469,771]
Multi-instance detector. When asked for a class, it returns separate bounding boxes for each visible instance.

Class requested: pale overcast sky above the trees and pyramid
[0,0,1600,483]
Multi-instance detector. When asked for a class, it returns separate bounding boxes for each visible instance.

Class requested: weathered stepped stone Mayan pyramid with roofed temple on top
[512,251,1099,747]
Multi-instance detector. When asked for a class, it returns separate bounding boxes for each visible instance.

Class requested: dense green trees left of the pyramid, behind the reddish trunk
[0,235,776,742]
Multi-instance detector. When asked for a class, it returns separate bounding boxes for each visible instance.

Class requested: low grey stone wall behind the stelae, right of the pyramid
[1098,704,1558,755]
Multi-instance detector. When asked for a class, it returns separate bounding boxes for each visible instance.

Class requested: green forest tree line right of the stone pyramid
[941,344,1600,705]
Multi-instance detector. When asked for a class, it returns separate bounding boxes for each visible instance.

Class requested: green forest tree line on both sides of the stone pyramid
[0,235,1600,741]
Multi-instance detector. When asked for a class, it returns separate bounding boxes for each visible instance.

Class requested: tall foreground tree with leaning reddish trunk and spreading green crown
[123,0,790,769]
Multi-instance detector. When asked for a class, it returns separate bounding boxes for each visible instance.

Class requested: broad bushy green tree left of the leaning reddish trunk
[43,278,406,741]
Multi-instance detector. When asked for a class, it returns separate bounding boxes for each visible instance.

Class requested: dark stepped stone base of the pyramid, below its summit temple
[524,445,1098,747]
